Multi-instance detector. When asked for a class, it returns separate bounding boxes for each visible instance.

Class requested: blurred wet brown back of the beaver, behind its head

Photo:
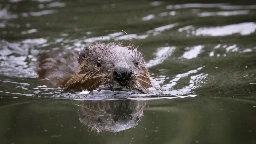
[36,50,79,86]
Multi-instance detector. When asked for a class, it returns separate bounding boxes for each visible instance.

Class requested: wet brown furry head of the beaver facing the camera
[64,43,151,93]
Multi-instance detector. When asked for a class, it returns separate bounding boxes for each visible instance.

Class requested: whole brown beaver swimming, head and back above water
[36,43,152,93]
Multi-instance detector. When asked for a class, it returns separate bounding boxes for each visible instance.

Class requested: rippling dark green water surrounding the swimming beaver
[0,0,256,144]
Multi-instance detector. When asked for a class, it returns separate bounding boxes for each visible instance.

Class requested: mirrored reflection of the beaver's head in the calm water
[78,100,146,132]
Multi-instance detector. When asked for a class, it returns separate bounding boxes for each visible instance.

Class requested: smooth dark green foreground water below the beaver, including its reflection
[0,98,256,144]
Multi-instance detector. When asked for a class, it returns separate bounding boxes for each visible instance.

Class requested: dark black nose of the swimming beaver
[113,67,132,86]
